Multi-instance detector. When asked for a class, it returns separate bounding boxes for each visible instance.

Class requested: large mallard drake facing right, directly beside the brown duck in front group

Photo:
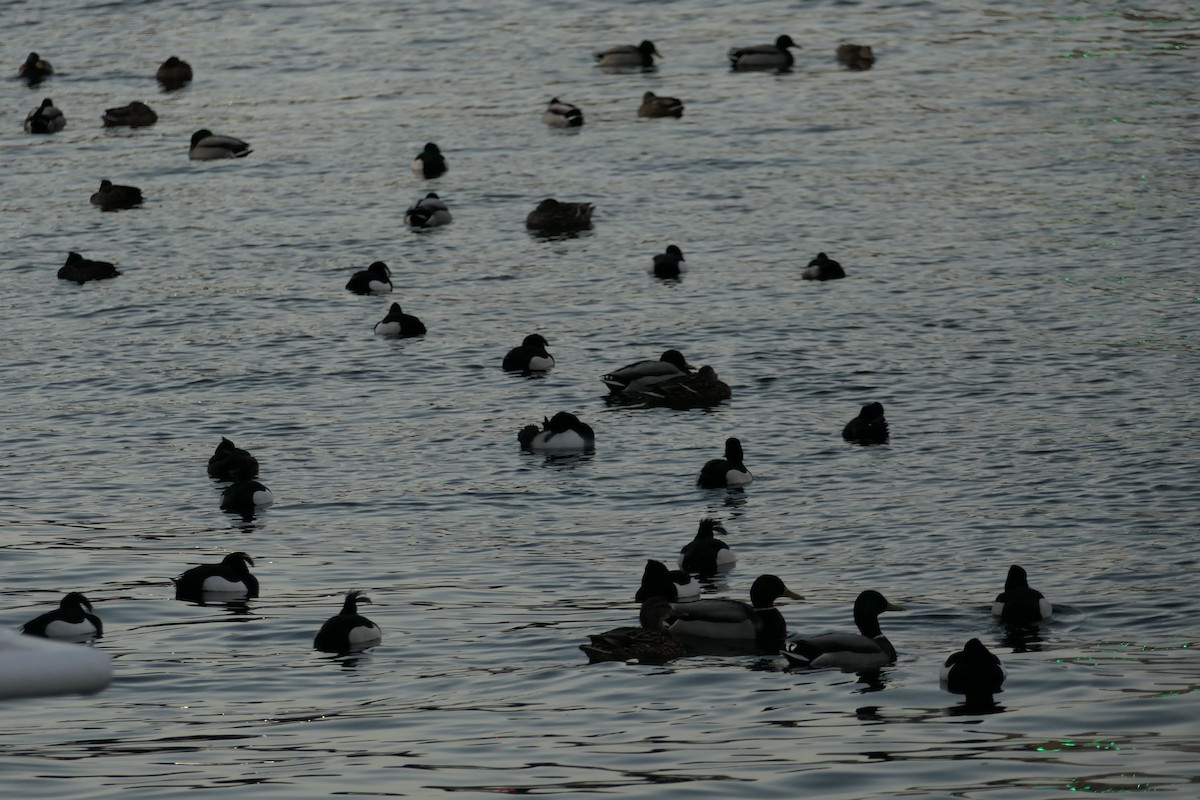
[671,575,804,650]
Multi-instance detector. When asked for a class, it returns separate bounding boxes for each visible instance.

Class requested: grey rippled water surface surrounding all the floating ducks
[0,0,1200,800]
